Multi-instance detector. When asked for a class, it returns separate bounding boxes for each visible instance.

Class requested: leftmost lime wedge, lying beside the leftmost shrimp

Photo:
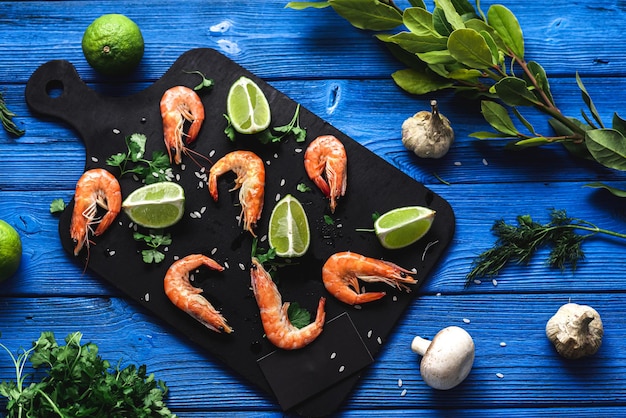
[122,181,185,229]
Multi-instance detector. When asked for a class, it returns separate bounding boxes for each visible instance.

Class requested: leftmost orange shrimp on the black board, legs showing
[70,168,122,255]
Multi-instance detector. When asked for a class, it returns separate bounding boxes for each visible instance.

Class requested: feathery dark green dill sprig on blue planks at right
[465,209,626,286]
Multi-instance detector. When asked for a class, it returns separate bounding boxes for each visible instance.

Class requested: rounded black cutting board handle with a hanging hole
[25,60,98,125]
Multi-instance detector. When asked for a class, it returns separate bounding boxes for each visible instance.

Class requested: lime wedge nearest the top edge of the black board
[226,76,272,134]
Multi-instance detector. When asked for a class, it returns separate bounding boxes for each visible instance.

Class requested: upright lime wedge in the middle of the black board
[267,194,311,258]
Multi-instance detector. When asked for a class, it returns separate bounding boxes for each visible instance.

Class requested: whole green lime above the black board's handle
[82,14,144,76]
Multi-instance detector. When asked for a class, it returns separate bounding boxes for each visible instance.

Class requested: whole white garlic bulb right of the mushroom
[546,303,604,359]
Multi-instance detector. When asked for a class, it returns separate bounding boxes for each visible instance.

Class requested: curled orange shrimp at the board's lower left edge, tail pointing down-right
[163,254,233,333]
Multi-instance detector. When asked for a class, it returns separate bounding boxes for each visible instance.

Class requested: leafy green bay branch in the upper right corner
[287,0,626,189]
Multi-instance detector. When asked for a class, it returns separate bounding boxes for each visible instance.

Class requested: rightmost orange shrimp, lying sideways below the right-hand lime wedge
[322,251,417,305]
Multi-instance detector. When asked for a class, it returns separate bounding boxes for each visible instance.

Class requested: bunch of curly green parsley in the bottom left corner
[0,332,175,418]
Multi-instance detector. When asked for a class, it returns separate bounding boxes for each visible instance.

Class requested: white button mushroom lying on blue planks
[411,326,474,390]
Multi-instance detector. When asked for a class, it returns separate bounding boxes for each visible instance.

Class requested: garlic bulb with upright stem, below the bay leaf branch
[402,100,454,158]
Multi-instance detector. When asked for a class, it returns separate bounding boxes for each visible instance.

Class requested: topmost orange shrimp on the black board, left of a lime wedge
[161,86,204,164]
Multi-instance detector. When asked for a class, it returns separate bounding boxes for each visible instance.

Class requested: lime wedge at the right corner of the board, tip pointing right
[374,206,436,249]
